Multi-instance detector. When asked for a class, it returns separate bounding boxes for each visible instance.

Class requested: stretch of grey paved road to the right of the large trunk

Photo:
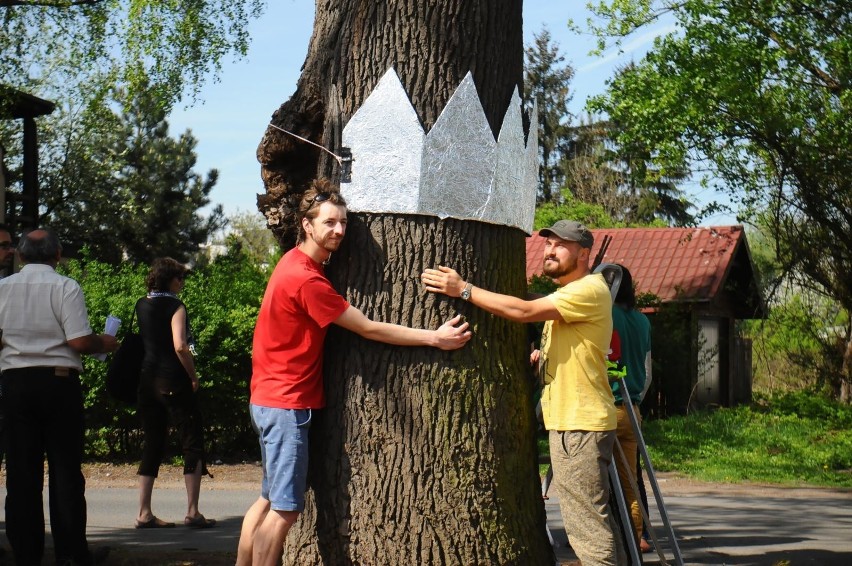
[546,482,852,566]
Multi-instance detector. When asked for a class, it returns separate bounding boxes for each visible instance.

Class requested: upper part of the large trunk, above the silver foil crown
[257,0,523,247]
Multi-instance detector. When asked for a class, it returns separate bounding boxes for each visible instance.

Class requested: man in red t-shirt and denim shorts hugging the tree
[237,179,471,566]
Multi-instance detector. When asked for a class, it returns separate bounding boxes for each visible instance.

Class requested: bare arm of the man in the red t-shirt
[334,306,471,350]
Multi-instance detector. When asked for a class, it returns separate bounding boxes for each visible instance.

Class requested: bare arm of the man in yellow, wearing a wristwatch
[420,265,561,322]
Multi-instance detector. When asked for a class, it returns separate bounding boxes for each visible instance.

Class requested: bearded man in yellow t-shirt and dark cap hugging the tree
[421,220,627,566]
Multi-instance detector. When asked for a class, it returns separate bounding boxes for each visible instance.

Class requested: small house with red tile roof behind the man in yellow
[526,226,765,415]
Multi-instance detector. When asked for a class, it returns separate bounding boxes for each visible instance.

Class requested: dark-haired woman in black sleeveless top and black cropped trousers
[136,257,216,529]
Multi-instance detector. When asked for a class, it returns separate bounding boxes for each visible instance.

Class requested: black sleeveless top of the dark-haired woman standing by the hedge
[136,296,189,380]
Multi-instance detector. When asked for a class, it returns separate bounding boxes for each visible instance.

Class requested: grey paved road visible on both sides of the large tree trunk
[0,485,852,566]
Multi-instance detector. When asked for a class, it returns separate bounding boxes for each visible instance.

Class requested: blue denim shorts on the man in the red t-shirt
[251,405,312,513]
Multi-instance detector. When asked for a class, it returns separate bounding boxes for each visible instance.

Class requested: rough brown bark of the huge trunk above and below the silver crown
[258,0,553,566]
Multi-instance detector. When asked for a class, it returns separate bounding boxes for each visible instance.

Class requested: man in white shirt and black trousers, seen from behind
[0,230,118,566]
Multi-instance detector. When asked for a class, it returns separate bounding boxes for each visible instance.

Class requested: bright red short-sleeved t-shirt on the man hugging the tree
[251,248,349,409]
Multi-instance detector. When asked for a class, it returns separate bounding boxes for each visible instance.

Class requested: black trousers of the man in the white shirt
[2,368,91,566]
